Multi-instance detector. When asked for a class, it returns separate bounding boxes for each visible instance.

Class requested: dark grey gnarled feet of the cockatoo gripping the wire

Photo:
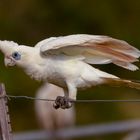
[53,96,72,109]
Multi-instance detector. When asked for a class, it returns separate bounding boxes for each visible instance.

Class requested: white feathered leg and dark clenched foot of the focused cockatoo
[54,84,77,109]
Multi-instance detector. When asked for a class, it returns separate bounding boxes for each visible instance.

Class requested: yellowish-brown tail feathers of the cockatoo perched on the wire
[104,78,140,90]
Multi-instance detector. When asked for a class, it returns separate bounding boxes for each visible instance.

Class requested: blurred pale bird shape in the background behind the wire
[35,83,75,131]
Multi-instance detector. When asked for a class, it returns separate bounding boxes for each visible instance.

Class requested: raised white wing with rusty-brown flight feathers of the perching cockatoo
[36,34,140,71]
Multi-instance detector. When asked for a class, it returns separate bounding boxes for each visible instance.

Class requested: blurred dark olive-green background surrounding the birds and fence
[0,0,140,140]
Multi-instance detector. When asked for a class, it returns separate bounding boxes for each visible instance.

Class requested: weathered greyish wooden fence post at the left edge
[0,84,12,140]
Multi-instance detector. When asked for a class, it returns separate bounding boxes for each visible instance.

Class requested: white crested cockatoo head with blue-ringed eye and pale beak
[0,41,33,66]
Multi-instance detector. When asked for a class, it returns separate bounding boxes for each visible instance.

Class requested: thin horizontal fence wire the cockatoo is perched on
[1,95,140,103]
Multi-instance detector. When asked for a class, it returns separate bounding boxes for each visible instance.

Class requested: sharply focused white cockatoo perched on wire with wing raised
[0,34,140,108]
